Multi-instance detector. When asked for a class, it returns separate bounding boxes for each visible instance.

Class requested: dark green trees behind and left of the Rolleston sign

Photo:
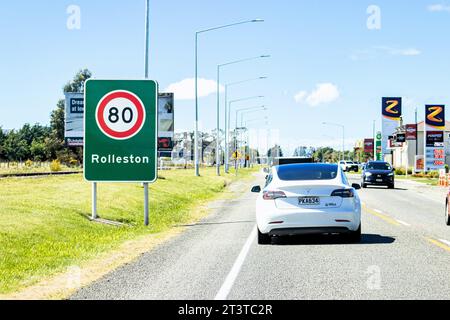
[0,69,92,164]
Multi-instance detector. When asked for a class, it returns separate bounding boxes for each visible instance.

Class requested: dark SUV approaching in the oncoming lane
[361,161,395,189]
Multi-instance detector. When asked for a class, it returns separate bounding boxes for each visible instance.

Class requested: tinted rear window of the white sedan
[277,164,338,181]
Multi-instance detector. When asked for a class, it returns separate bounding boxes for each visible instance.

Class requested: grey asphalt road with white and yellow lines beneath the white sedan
[72,172,450,300]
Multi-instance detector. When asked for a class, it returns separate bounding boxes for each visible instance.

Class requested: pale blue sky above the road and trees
[0,0,450,155]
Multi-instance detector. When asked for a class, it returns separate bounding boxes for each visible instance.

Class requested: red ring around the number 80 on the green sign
[96,91,145,140]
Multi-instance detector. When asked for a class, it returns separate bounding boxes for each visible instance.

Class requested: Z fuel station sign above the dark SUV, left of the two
[381,98,402,154]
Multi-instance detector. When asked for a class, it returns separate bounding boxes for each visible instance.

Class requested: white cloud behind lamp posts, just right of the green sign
[165,78,224,100]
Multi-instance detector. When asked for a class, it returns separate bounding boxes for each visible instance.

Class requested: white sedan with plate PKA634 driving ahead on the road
[252,164,361,244]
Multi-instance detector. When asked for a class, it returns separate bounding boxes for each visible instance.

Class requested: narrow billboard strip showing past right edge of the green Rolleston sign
[158,93,175,152]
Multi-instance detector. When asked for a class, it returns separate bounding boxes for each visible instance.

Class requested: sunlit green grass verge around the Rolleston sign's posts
[0,169,256,294]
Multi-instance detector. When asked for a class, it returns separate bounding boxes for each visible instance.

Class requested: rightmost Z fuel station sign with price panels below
[424,105,445,171]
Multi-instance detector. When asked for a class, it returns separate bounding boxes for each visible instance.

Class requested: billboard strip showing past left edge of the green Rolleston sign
[64,92,84,147]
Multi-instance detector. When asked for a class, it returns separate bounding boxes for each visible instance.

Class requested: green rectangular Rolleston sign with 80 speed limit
[84,80,158,182]
